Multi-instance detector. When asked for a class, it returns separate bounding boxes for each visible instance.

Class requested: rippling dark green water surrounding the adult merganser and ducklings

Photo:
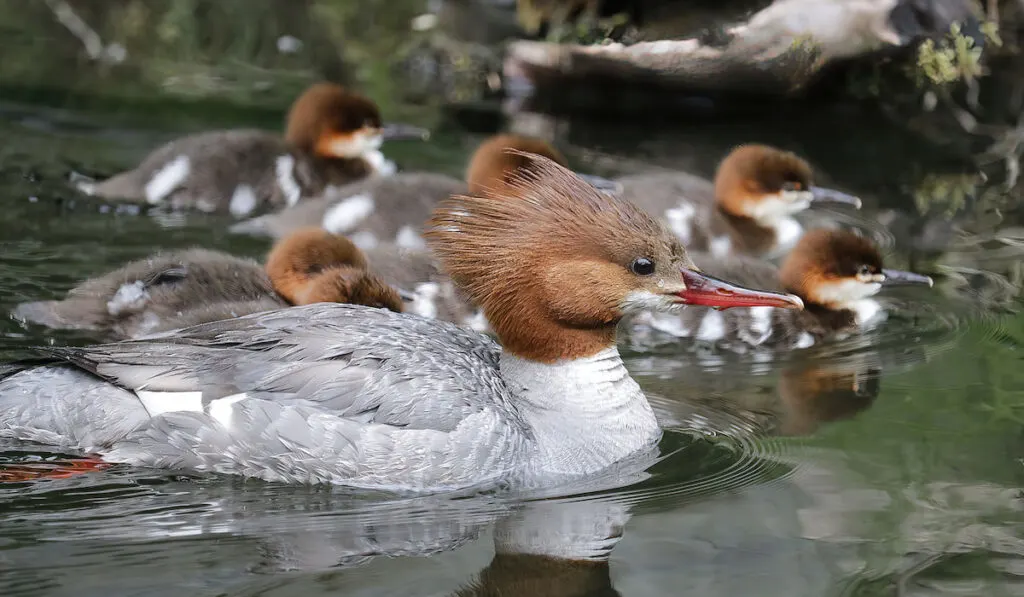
[0,5,1024,597]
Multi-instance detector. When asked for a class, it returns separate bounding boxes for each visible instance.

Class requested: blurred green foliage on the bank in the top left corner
[0,0,425,123]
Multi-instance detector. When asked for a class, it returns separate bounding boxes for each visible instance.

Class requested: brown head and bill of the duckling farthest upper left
[285,83,428,160]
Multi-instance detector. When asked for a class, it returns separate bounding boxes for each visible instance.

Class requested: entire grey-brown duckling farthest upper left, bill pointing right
[79,83,427,217]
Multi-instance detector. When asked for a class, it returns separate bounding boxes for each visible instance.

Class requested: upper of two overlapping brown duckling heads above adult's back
[264,226,367,304]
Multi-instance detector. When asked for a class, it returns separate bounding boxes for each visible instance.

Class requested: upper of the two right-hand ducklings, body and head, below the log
[617,145,860,258]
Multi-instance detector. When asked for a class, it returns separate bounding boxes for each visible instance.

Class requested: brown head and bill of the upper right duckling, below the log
[715,144,860,225]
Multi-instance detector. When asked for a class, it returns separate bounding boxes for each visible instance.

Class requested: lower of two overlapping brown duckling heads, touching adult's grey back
[292,265,402,313]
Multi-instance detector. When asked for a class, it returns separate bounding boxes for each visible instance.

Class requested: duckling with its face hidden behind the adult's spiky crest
[230,134,614,249]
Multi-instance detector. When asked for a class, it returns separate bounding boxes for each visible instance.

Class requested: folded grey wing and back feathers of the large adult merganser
[48,304,514,431]
